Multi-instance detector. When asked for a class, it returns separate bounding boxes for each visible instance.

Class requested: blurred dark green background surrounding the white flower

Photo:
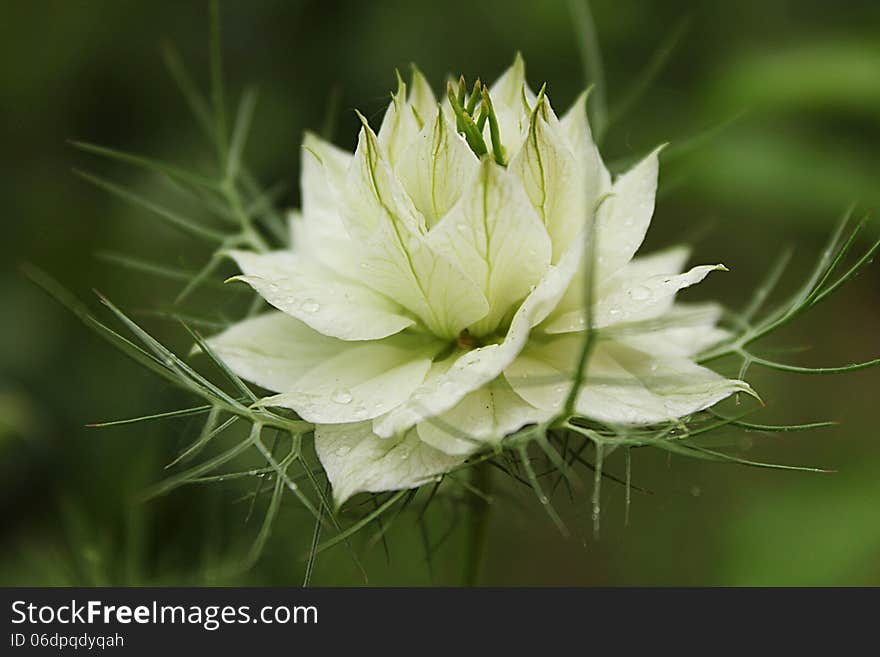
[0,0,880,585]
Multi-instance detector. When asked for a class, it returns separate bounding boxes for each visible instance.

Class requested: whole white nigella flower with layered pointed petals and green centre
[211,58,748,503]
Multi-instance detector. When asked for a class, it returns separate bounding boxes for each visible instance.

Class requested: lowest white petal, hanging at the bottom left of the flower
[315,422,464,506]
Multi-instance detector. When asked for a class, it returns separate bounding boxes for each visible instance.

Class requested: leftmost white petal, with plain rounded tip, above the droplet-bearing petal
[208,312,346,391]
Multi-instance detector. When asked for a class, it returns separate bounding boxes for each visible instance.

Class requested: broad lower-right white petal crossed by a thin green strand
[505,335,751,425]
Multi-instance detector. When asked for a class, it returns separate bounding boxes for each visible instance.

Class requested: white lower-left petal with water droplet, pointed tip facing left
[261,334,443,424]
